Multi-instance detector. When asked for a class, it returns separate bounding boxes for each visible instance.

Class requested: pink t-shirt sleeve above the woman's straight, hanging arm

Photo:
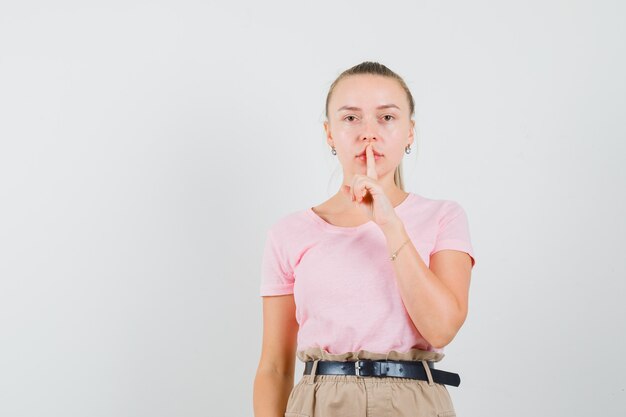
[259,229,294,296]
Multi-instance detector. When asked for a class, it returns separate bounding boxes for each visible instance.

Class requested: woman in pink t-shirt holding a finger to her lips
[254,62,475,417]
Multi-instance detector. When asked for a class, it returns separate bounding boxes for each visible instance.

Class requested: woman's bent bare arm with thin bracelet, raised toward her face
[383,218,471,348]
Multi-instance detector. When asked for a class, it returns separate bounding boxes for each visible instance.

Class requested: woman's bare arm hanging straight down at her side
[253,294,298,417]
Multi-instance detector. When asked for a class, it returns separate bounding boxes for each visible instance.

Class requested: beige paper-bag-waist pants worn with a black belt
[285,348,456,417]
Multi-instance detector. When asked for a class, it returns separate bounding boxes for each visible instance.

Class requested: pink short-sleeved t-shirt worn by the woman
[260,192,475,354]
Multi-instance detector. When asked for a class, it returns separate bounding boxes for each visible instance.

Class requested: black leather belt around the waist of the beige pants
[304,359,461,387]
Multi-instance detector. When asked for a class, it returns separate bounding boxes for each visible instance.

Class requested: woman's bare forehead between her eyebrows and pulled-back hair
[329,74,408,110]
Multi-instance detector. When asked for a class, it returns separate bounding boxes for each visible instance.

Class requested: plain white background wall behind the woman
[0,0,626,417]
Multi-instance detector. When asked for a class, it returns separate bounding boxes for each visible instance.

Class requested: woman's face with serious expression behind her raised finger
[324,74,415,178]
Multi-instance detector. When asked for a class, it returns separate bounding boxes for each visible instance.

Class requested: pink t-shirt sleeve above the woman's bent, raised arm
[430,201,476,267]
